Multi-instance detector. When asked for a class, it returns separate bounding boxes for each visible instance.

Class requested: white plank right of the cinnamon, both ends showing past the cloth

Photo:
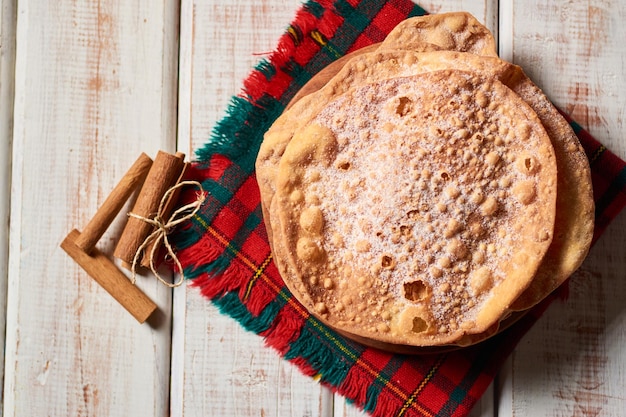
[172,0,330,417]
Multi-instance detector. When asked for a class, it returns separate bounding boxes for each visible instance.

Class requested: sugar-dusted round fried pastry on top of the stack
[271,70,556,346]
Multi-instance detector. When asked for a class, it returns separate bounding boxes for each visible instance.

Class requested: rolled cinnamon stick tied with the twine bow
[113,151,185,267]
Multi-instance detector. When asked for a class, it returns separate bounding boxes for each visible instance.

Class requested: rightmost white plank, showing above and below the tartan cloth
[499,0,626,416]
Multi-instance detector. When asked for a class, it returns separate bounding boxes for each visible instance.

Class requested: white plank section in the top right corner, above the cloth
[502,0,626,153]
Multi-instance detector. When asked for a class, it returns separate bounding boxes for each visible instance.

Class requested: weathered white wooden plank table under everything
[0,0,626,417]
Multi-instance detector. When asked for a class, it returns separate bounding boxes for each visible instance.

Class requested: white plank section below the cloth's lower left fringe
[172,289,329,417]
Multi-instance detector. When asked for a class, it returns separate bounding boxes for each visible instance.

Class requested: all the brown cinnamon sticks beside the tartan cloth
[61,151,189,323]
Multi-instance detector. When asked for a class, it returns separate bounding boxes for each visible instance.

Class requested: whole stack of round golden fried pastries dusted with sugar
[256,13,594,352]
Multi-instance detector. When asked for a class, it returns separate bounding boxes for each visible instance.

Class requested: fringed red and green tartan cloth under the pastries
[173,0,626,417]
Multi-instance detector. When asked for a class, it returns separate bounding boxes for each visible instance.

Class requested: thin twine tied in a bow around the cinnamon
[128,181,206,288]
